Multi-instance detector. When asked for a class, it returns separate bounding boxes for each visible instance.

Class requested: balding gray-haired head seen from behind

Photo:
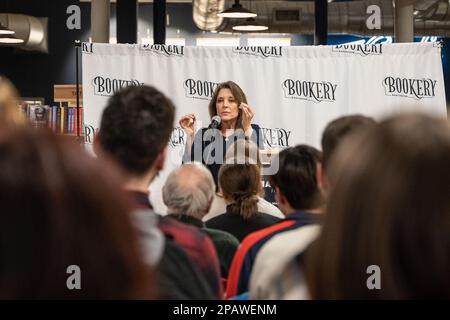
[163,163,216,219]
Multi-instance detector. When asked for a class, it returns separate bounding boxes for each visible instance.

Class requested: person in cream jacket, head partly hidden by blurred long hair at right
[250,115,375,299]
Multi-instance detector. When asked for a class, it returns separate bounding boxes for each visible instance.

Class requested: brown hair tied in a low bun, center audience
[219,164,262,219]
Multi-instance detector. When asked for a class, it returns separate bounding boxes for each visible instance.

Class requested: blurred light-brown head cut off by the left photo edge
[0,76,25,127]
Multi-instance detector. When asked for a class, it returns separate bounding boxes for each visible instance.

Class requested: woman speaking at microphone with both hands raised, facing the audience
[179,81,263,186]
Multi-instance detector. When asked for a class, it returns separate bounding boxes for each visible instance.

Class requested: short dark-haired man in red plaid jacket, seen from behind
[95,86,223,299]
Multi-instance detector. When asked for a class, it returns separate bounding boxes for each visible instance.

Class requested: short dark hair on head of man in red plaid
[99,86,175,175]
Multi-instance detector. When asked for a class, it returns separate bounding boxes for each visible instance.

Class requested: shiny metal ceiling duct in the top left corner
[0,13,48,53]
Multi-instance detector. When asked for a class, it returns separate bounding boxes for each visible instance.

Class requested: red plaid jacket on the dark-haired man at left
[126,191,223,299]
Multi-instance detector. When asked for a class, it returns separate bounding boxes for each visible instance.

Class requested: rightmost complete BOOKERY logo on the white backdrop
[383,76,437,100]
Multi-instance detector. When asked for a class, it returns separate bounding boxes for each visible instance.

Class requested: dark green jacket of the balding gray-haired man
[169,214,239,278]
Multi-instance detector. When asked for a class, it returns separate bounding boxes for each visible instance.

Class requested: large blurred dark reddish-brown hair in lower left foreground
[0,130,153,299]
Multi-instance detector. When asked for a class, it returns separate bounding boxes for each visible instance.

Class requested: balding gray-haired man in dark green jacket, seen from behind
[162,163,239,278]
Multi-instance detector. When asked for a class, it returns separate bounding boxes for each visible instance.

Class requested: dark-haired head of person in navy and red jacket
[269,145,323,210]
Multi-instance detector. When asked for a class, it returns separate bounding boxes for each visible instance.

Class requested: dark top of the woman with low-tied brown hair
[206,206,280,242]
